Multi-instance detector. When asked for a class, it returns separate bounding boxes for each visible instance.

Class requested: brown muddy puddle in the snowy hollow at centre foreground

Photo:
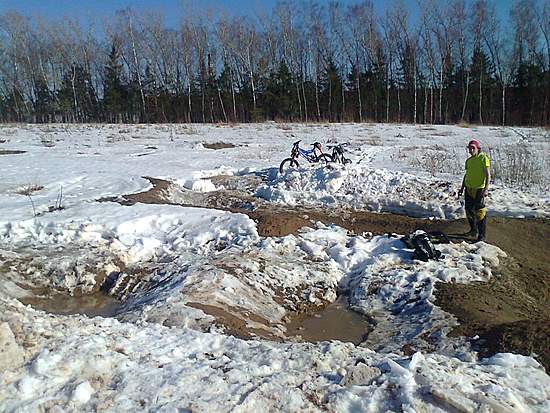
[286,296,372,345]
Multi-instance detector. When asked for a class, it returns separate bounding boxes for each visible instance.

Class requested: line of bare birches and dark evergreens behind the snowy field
[0,0,550,125]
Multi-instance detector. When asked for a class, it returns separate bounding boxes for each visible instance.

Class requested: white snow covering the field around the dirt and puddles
[0,124,550,412]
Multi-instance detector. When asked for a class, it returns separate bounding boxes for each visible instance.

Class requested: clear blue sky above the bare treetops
[0,0,513,27]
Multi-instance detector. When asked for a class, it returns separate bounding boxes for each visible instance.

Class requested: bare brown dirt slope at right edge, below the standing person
[436,218,550,371]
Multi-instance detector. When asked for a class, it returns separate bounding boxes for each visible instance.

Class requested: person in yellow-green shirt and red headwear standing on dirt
[458,139,491,241]
